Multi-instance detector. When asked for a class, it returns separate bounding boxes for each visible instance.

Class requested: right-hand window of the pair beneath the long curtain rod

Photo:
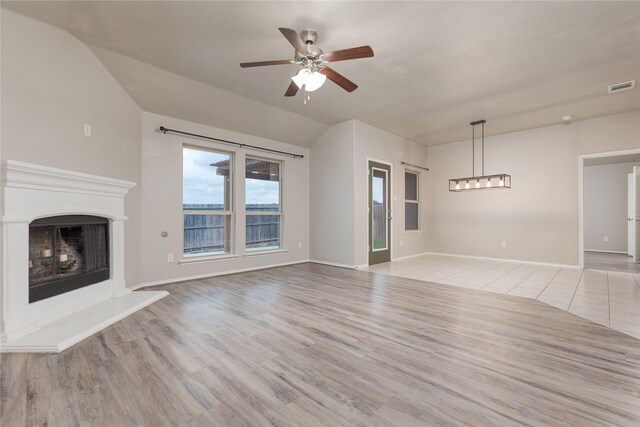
[245,157,282,251]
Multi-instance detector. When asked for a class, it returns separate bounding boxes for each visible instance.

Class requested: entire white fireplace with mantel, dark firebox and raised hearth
[0,159,168,353]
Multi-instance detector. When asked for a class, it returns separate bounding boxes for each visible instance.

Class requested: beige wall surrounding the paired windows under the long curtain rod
[139,112,309,284]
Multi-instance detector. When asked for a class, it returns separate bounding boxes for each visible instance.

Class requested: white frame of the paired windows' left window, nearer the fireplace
[181,143,236,261]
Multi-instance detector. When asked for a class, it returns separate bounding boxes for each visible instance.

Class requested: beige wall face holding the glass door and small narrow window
[353,120,429,266]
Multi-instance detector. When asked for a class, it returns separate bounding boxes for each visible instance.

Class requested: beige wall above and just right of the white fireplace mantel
[0,8,141,286]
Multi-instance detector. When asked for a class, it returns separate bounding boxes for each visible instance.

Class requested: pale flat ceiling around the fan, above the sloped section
[2,1,640,145]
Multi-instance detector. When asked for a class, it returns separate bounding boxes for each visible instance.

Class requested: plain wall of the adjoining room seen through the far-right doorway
[583,163,640,254]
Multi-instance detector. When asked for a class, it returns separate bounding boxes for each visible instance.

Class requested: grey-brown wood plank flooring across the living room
[0,264,640,427]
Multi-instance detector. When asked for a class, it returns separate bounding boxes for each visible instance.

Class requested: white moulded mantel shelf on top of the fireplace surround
[0,159,136,198]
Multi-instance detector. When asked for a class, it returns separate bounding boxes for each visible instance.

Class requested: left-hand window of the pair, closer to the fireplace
[182,146,233,256]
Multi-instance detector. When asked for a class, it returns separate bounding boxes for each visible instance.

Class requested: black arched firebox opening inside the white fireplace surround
[29,215,109,303]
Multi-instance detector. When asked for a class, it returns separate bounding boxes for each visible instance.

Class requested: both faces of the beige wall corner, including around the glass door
[311,120,428,267]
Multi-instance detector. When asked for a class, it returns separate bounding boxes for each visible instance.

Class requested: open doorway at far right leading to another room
[579,150,640,273]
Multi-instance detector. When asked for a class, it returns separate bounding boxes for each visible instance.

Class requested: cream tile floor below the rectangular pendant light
[367,255,640,338]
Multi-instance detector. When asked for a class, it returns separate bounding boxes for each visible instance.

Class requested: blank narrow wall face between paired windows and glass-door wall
[309,120,355,267]
